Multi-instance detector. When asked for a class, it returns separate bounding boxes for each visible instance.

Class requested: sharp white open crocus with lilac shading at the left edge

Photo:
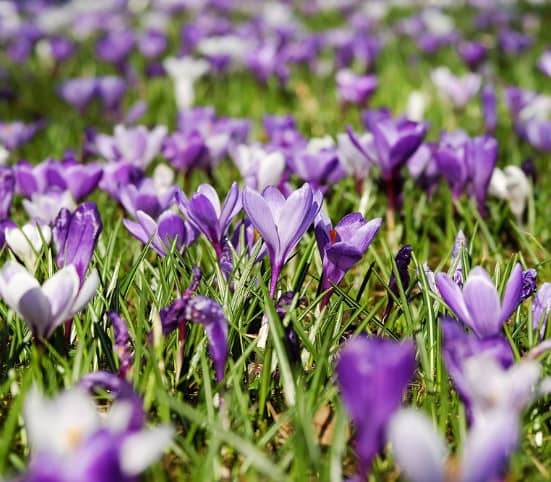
[0,261,99,338]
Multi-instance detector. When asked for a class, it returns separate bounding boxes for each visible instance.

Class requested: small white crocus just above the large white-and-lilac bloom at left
[5,223,52,271]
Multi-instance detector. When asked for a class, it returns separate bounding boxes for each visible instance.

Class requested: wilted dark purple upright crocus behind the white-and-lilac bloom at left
[52,202,103,284]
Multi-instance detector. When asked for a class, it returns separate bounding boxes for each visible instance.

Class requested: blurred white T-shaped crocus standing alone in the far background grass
[163,57,209,110]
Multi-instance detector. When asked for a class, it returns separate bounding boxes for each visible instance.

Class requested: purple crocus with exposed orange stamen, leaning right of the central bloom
[315,212,382,304]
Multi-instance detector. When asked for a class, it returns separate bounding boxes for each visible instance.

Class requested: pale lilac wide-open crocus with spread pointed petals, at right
[436,263,522,339]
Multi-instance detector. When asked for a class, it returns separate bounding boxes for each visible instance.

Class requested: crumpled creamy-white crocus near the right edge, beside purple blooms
[489,166,532,224]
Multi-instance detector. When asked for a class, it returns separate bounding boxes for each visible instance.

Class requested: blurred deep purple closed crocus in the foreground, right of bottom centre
[336,336,415,479]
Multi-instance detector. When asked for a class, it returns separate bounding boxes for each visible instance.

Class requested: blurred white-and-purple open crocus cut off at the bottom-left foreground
[18,387,173,482]
